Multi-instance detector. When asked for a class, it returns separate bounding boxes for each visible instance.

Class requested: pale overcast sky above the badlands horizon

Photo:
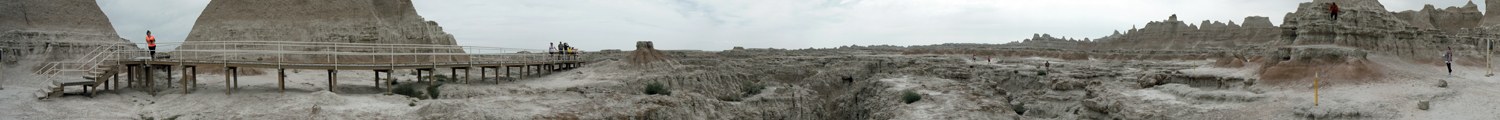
[98,0,1485,51]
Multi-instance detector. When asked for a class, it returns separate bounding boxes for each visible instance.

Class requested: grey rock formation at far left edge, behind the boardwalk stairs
[0,0,144,65]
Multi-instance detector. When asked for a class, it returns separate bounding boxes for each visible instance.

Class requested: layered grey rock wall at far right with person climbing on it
[1278,0,1493,59]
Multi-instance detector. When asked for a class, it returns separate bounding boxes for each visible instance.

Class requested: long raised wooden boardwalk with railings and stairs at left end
[98,59,584,95]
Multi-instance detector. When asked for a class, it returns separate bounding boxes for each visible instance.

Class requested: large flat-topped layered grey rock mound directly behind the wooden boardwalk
[179,0,467,62]
